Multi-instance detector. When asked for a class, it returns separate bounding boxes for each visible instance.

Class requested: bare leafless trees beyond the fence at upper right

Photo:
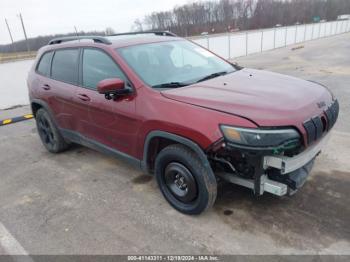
[134,0,350,36]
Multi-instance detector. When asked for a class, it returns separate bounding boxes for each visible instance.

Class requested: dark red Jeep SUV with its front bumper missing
[28,32,339,214]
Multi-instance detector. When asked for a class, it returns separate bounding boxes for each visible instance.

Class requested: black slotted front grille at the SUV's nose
[303,100,339,145]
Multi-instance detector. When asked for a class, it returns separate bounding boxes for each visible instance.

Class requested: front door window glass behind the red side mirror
[83,49,126,89]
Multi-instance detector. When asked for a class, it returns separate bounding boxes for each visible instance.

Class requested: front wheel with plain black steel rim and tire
[155,144,217,215]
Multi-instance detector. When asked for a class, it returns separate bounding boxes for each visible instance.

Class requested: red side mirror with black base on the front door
[97,78,131,100]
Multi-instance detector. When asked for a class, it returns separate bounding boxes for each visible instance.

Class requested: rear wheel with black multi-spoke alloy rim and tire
[35,108,69,153]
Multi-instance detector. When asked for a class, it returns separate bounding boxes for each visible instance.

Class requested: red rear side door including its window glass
[47,48,80,130]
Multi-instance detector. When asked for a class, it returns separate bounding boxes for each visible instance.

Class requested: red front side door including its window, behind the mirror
[74,48,138,154]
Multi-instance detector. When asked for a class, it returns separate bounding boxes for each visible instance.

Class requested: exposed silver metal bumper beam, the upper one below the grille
[263,133,330,174]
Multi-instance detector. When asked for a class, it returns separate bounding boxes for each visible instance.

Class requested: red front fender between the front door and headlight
[135,87,257,159]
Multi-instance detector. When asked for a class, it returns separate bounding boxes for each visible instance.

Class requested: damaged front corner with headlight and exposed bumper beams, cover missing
[207,126,329,196]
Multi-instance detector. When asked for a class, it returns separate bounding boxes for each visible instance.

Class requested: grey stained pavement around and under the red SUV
[0,31,350,254]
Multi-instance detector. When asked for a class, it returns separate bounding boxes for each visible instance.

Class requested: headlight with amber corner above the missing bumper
[220,125,300,147]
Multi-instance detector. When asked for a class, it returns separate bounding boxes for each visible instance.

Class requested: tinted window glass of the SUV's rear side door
[51,49,79,85]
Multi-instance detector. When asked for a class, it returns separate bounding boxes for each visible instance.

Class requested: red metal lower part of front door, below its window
[74,87,140,156]
